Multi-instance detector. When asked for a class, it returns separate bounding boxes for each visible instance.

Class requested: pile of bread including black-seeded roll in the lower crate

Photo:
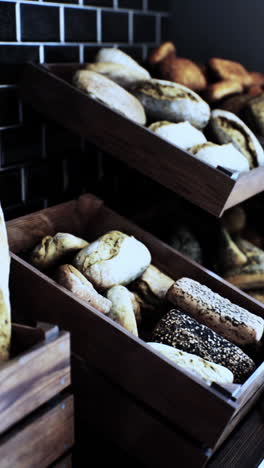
[30,231,264,383]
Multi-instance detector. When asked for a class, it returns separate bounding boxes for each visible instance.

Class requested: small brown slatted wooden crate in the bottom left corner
[0,322,74,468]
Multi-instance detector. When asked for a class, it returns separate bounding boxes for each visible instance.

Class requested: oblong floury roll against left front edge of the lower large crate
[55,265,111,314]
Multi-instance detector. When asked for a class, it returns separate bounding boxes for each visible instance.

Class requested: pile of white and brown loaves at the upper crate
[73,46,264,173]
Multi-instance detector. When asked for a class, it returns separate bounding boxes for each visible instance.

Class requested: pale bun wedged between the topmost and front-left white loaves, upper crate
[85,62,149,88]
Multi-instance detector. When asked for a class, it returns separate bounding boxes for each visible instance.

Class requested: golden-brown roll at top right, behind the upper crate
[208,57,252,86]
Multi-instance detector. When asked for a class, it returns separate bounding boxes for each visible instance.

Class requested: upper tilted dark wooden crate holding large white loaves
[20,64,264,216]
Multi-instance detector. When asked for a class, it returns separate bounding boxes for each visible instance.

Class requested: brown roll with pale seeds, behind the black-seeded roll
[167,278,264,345]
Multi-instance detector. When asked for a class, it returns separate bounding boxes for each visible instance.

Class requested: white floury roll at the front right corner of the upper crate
[188,141,249,172]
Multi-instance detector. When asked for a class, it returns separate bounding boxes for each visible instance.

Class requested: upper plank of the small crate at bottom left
[0,332,70,436]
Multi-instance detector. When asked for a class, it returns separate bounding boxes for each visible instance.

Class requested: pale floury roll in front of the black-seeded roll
[148,342,234,383]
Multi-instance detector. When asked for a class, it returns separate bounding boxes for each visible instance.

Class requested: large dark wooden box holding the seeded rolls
[7,194,264,467]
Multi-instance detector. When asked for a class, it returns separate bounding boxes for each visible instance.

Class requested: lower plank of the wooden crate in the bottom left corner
[0,395,74,468]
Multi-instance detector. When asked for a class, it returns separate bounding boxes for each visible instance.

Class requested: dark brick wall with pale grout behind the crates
[0,0,168,219]
